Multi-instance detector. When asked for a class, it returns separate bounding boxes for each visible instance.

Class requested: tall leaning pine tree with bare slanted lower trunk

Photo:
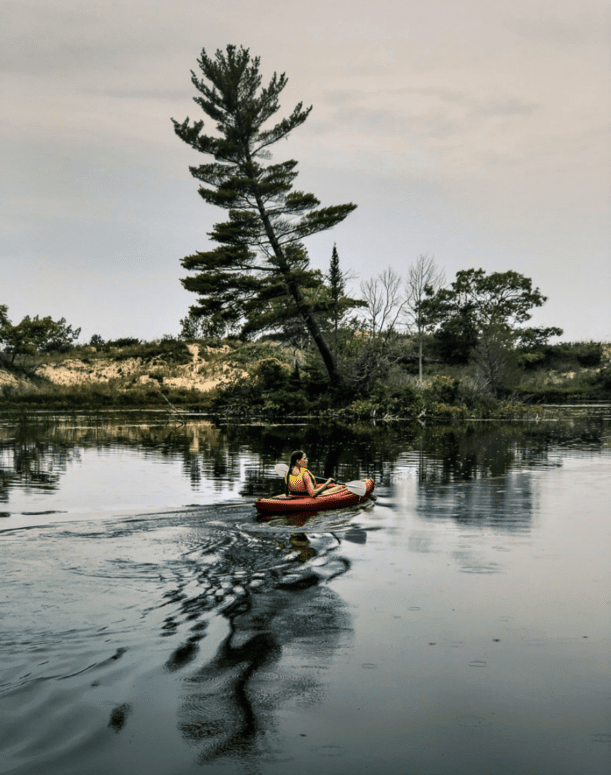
[173,45,356,387]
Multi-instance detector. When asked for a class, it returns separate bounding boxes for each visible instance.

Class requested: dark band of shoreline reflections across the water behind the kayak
[0,412,610,529]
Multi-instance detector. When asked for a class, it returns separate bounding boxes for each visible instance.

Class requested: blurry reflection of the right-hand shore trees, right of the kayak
[392,417,609,532]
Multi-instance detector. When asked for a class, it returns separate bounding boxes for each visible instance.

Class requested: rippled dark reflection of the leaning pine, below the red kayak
[160,533,352,763]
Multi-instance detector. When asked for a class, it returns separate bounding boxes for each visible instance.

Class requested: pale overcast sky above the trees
[0,0,611,341]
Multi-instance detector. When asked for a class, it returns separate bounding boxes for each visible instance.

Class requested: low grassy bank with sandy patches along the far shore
[0,339,611,421]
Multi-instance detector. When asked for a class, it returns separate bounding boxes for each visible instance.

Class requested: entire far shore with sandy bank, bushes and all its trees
[0,46,611,422]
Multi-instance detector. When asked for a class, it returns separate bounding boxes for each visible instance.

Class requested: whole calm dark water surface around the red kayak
[0,407,611,775]
